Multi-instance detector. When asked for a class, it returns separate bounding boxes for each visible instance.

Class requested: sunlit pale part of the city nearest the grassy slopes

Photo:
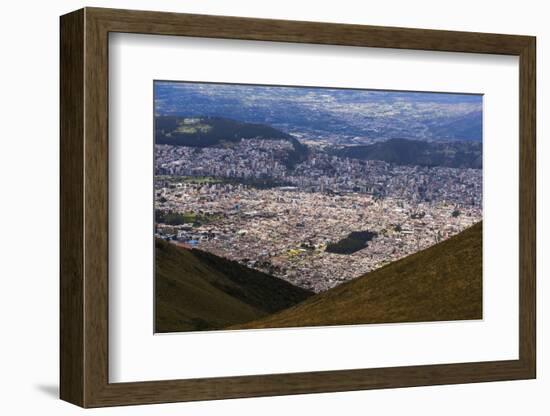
[155,177,482,292]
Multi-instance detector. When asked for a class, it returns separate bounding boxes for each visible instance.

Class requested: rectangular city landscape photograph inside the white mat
[153,80,483,333]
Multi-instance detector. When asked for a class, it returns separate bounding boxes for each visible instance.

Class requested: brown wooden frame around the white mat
[60,8,536,407]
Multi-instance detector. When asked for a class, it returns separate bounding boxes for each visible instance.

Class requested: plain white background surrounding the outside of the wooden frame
[0,0,550,416]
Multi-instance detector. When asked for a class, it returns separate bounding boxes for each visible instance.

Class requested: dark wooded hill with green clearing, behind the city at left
[155,116,308,166]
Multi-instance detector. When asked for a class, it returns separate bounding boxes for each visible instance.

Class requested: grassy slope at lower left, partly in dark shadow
[155,240,312,332]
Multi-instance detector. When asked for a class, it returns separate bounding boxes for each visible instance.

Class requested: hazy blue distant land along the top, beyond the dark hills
[154,81,482,144]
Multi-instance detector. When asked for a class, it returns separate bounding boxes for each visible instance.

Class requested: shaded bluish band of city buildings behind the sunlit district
[155,143,482,208]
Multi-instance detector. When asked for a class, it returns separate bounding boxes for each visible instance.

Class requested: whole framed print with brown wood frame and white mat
[60,8,536,407]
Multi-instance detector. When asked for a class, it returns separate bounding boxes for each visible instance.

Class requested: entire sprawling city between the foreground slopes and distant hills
[155,139,482,292]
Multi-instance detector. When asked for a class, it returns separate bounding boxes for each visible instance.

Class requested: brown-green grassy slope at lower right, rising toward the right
[232,223,482,329]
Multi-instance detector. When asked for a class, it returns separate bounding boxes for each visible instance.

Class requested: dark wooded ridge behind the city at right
[332,139,482,169]
